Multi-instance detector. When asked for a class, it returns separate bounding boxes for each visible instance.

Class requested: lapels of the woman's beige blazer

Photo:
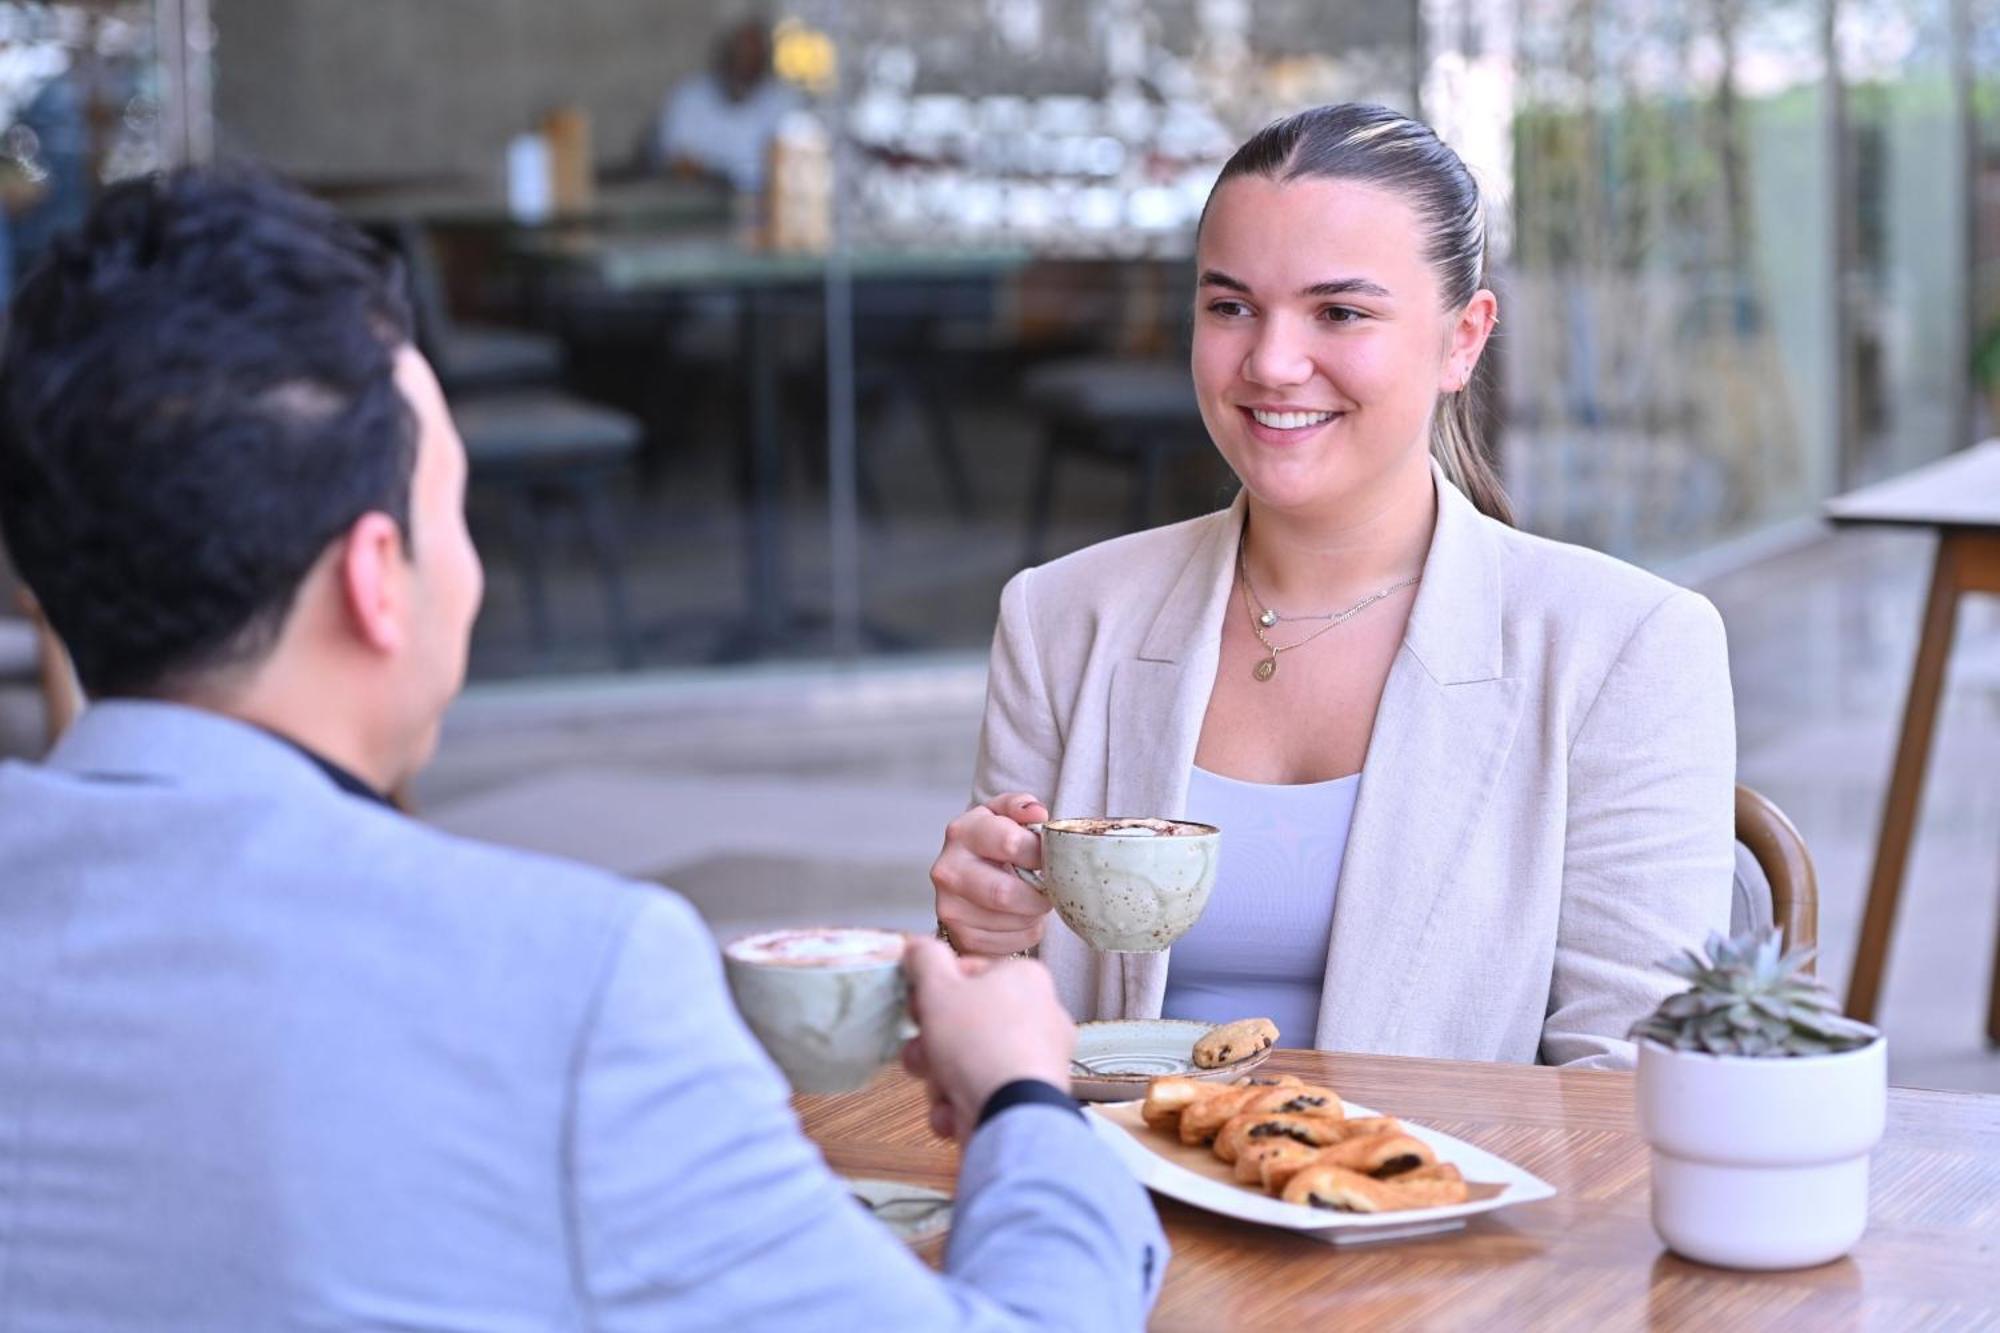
[1096,464,1520,1024]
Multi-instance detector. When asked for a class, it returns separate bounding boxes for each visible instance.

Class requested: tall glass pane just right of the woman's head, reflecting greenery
[1464,0,1836,558]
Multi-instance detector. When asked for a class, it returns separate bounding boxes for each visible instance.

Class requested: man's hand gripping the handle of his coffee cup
[902,939,1076,1141]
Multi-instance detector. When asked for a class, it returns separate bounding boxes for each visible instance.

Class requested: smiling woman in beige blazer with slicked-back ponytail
[932,106,1736,1065]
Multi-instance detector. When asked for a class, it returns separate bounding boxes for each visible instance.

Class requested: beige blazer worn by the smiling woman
[974,474,1736,1067]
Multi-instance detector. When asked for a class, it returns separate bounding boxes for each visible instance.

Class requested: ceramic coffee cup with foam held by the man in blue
[722,927,910,1093]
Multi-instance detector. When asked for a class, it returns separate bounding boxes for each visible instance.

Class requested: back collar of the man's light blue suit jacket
[48,699,368,797]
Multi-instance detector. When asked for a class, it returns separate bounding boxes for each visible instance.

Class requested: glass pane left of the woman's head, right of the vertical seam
[832,0,1422,650]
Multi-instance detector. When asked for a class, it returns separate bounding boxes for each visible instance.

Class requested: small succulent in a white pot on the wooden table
[1632,931,1888,1269]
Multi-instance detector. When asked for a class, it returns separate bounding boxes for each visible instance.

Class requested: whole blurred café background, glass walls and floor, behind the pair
[0,0,2000,1085]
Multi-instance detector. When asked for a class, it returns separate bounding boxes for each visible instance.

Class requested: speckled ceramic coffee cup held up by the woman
[1014,819,1222,953]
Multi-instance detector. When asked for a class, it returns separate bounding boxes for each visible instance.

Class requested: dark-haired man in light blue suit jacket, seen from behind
[0,172,1166,1333]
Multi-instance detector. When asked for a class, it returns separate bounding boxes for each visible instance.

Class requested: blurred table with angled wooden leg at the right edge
[1826,440,2000,1043]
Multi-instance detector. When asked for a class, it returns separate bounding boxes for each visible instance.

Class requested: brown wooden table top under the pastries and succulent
[798,1051,2000,1333]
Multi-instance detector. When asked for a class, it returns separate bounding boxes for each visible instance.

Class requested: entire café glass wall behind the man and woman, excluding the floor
[184,0,2000,679]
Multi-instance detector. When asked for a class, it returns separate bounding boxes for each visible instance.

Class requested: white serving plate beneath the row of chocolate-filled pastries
[1086,1101,1556,1245]
